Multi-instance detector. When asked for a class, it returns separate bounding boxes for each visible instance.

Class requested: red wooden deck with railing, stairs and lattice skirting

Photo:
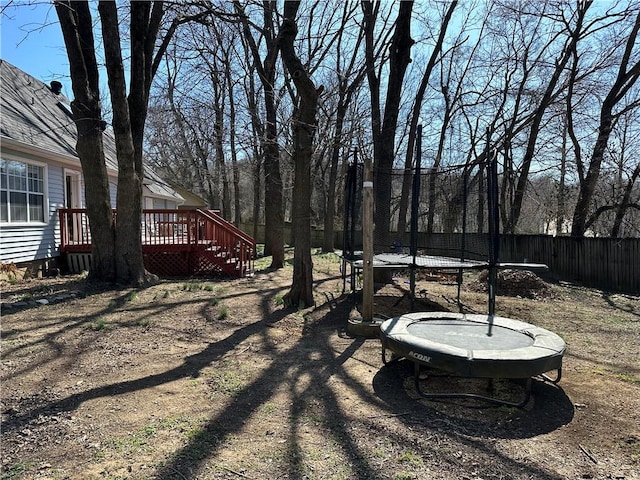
[59,208,256,277]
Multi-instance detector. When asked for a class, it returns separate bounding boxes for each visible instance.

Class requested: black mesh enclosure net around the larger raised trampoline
[343,163,490,261]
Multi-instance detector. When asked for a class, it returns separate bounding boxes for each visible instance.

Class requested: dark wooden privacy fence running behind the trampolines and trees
[244,225,640,294]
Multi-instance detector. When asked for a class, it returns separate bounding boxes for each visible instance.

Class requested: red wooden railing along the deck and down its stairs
[58,208,256,275]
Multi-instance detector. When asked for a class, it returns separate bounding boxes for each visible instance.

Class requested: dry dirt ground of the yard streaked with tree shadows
[0,255,640,480]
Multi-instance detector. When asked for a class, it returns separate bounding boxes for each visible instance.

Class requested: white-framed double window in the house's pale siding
[0,159,44,223]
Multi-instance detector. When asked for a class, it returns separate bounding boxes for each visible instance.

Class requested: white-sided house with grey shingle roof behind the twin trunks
[0,59,184,276]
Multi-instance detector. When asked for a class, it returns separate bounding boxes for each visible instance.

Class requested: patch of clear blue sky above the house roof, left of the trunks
[0,0,71,89]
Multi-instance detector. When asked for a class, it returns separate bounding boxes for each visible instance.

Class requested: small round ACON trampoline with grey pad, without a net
[380,312,566,406]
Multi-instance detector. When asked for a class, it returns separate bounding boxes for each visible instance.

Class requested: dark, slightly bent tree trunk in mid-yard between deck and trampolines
[280,1,319,307]
